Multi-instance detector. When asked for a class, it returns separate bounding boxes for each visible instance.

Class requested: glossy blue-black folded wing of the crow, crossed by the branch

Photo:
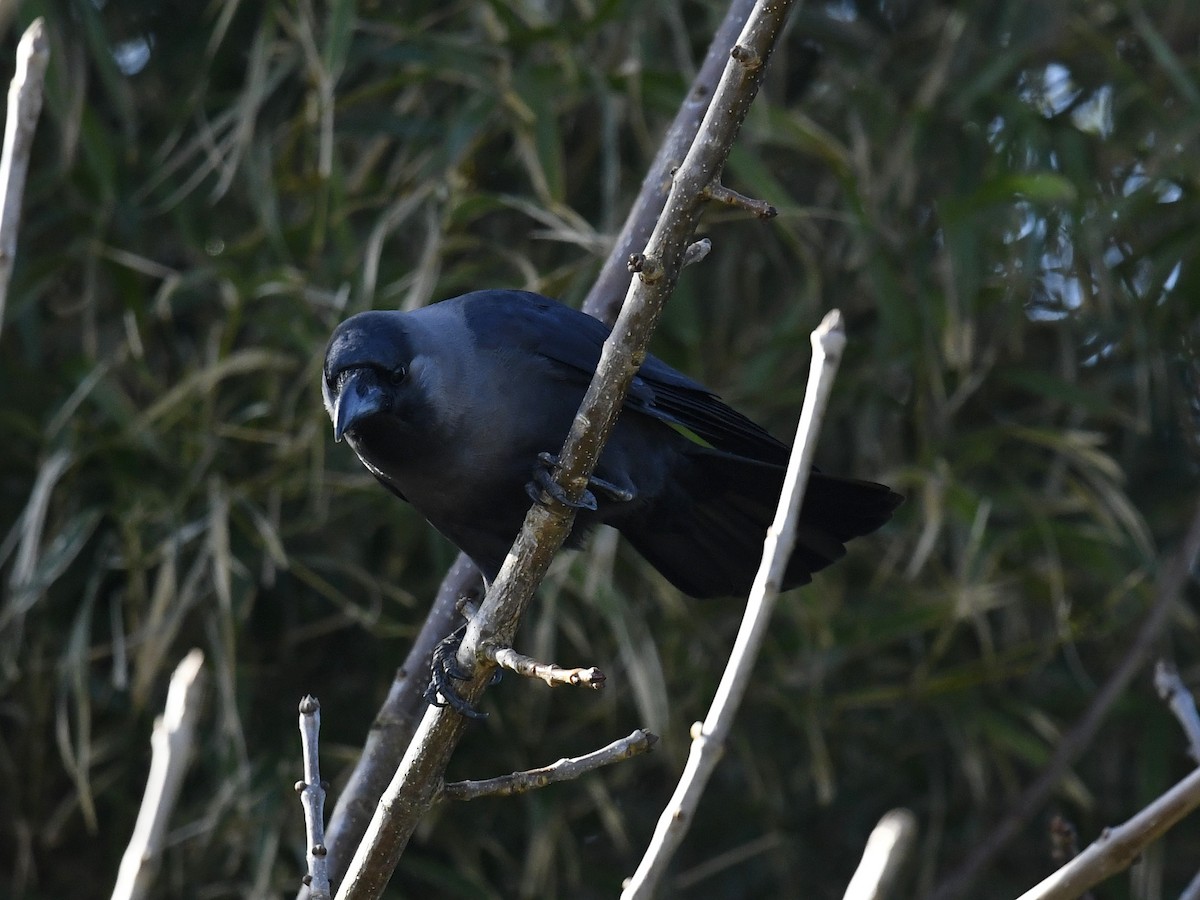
[464,290,788,466]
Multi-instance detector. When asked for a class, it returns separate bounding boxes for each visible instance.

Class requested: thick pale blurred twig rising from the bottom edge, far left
[113,650,204,900]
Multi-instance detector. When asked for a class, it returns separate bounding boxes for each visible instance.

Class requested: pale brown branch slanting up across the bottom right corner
[1018,769,1200,900]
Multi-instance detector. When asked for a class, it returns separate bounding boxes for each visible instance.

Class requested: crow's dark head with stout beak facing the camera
[322,311,416,444]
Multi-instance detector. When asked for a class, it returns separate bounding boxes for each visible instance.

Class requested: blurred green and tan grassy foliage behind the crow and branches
[0,0,1200,898]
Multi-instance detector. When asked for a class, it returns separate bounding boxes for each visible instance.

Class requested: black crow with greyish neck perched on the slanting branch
[322,290,901,598]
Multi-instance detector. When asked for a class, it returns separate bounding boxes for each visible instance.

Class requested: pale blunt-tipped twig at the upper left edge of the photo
[0,17,50,340]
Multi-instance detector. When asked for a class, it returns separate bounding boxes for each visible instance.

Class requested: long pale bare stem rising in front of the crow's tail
[622,310,846,900]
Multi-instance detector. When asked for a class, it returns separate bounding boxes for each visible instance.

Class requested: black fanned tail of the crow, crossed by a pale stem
[613,449,902,598]
